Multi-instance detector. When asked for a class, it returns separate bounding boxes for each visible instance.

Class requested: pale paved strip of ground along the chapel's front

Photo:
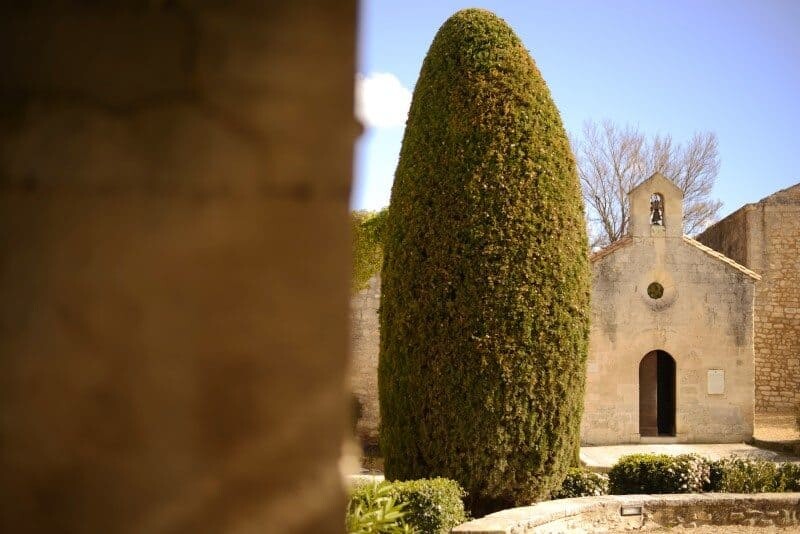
[581,443,800,472]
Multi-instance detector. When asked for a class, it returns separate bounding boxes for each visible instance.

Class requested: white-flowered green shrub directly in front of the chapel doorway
[608,454,709,495]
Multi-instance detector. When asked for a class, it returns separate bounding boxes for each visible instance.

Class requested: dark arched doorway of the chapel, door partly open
[639,350,675,436]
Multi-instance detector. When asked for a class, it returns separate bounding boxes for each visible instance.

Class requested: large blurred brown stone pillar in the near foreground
[0,0,357,534]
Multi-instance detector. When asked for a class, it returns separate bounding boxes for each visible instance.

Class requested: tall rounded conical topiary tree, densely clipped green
[379,9,589,511]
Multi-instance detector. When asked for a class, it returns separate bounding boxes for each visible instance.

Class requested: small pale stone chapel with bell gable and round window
[581,174,760,445]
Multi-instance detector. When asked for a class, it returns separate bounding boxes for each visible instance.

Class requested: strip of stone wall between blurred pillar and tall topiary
[350,275,381,446]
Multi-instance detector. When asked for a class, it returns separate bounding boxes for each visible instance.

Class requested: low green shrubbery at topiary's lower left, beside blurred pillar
[348,478,467,534]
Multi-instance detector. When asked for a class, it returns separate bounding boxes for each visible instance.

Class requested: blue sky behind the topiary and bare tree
[351,0,800,220]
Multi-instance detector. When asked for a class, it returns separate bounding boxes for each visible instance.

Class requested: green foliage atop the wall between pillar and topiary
[350,208,386,291]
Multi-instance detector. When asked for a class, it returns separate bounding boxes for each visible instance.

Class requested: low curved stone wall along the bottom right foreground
[452,493,800,534]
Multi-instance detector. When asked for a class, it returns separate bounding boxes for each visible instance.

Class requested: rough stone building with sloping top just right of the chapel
[698,184,800,414]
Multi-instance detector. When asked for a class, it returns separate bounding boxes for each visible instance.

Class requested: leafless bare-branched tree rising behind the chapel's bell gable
[572,119,722,248]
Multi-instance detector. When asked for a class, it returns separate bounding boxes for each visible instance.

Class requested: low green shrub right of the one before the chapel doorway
[708,457,778,493]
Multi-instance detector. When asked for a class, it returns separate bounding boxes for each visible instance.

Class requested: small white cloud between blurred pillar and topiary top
[356,72,411,128]
